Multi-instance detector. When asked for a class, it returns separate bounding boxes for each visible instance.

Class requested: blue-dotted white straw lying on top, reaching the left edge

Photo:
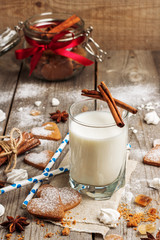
[0,166,69,194]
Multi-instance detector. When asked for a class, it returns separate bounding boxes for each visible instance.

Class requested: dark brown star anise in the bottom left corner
[0,216,29,233]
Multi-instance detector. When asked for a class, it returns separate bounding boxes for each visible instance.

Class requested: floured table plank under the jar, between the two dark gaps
[1,57,94,240]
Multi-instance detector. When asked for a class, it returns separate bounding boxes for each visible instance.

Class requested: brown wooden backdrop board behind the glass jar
[0,0,160,50]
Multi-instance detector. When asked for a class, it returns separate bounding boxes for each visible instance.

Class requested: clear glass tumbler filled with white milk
[69,99,128,200]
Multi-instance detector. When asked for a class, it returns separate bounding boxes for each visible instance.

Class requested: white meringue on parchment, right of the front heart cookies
[98,208,120,227]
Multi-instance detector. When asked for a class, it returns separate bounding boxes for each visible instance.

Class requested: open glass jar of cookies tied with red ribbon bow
[0,12,106,81]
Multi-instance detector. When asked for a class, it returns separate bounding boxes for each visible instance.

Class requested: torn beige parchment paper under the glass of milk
[47,153,137,237]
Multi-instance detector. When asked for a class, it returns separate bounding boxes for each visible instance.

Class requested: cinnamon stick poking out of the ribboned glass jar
[48,14,80,33]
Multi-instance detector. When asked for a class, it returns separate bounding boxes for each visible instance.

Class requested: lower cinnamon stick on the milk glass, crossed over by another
[82,89,137,114]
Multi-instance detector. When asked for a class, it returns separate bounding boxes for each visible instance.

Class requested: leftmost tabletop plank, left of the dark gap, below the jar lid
[0,51,20,135]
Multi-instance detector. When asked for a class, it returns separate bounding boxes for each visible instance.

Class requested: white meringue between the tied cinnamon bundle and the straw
[6,169,28,183]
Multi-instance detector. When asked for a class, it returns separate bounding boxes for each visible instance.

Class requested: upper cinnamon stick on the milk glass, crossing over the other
[98,85,124,127]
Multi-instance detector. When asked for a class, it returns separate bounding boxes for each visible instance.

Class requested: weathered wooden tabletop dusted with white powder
[0,51,160,240]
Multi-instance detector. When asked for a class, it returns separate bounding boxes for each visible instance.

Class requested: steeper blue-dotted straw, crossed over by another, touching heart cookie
[22,133,69,208]
